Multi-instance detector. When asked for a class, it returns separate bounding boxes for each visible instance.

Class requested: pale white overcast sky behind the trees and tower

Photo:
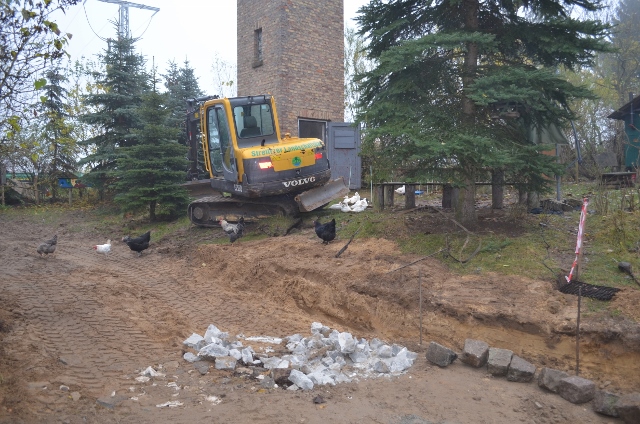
[54,0,368,94]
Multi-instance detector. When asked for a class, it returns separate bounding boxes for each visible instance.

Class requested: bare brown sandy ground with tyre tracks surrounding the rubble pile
[0,206,640,424]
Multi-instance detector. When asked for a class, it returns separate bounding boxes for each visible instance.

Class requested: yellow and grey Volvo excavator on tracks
[184,95,349,226]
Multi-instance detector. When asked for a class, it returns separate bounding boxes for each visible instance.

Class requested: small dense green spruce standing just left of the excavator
[114,76,189,221]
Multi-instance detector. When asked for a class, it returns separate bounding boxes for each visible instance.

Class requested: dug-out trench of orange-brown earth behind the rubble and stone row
[198,235,640,392]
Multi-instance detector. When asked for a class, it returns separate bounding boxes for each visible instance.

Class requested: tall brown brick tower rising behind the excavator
[237,0,344,141]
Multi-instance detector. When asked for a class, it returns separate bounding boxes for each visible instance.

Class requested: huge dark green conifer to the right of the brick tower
[358,0,608,224]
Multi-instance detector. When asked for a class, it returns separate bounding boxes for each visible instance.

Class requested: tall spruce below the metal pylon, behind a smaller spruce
[80,33,149,194]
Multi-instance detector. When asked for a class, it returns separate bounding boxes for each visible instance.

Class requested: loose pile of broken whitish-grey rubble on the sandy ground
[184,322,418,390]
